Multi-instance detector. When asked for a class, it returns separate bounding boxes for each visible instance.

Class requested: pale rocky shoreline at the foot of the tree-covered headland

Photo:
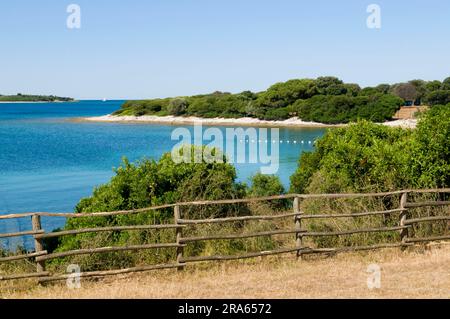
[78,114,417,128]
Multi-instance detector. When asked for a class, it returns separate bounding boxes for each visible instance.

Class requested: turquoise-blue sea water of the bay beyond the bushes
[0,101,324,249]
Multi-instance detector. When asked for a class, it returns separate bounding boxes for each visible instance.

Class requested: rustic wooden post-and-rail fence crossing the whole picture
[0,189,450,282]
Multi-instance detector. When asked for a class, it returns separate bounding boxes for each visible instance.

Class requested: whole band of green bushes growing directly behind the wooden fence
[41,104,450,270]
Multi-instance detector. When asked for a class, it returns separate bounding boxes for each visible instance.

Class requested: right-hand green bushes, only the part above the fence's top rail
[291,104,450,193]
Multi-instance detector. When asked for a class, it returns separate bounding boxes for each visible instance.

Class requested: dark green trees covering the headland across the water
[114,76,450,124]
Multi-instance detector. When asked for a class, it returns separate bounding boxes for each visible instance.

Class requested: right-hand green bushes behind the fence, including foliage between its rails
[291,104,450,247]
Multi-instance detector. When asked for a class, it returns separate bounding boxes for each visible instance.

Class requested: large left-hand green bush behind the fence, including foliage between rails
[53,147,250,269]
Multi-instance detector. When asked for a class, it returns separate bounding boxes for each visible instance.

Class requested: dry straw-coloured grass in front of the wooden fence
[0,245,450,298]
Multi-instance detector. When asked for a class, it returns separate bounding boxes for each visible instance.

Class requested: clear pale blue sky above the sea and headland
[0,0,450,99]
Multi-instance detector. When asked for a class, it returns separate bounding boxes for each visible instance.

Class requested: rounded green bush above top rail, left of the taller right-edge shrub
[291,121,411,193]
